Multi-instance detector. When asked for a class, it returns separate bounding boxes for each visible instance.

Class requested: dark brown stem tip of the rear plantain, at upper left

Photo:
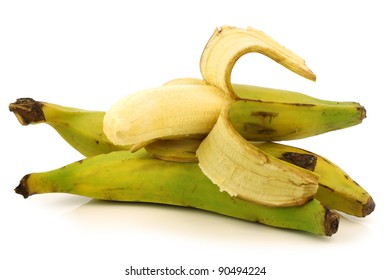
[8,98,46,125]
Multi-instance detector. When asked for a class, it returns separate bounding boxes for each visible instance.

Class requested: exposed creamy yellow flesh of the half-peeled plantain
[103,85,232,148]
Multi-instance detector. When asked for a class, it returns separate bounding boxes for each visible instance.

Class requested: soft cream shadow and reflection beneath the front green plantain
[63,200,370,244]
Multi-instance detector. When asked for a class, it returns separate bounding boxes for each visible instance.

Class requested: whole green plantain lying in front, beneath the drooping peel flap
[15,150,339,236]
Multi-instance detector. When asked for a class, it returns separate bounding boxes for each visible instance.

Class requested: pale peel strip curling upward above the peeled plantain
[200,26,316,97]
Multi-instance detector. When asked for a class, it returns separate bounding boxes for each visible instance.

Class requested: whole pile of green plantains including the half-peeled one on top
[9,26,375,236]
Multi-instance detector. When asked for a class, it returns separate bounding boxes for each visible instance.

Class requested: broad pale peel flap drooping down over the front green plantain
[196,107,318,207]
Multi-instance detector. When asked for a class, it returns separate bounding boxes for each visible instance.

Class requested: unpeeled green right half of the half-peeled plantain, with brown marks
[229,100,366,141]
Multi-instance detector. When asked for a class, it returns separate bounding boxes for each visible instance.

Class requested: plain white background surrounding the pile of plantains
[0,0,390,279]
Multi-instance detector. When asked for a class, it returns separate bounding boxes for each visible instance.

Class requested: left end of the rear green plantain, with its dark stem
[9,98,128,157]
